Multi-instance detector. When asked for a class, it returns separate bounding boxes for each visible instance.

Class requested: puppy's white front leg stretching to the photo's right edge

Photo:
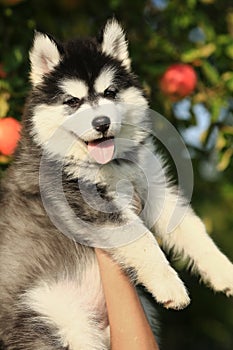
[149,188,233,296]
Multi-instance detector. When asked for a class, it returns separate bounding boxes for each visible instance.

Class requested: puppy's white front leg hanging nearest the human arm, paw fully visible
[108,231,189,309]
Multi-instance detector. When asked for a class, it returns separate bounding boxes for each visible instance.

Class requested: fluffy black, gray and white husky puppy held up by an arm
[0,20,233,350]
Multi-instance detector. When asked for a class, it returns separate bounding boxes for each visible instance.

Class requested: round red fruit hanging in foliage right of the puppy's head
[160,63,197,100]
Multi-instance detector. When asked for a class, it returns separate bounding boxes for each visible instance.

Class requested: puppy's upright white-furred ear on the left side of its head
[30,32,61,85]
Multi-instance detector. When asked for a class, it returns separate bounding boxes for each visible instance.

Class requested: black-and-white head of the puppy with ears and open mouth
[30,20,148,164]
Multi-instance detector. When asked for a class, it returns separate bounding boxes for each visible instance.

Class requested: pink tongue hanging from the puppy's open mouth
[87,139,115,164]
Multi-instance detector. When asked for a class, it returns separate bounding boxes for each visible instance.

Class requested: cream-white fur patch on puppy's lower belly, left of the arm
[18,274,109,350]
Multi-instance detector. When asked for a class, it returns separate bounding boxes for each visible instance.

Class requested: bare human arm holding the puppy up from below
[95,249,159,350]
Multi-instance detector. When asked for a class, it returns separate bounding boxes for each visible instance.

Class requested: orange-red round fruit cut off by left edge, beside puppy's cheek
[0,117,21,156]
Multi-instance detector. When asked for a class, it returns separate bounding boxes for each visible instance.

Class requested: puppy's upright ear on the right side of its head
[102,19,130,70]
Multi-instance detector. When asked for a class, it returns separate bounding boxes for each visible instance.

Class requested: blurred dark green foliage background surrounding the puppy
[0,0,233,350]
